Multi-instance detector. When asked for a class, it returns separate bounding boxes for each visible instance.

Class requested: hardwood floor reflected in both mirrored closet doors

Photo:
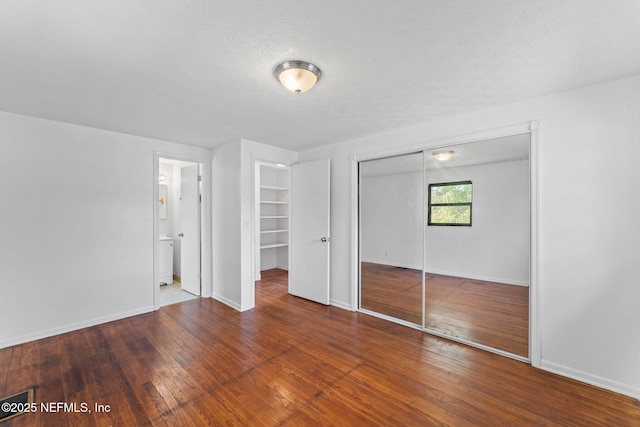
[361,262,529,357]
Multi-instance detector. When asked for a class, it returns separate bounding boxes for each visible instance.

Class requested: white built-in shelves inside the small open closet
[256,163,290,271]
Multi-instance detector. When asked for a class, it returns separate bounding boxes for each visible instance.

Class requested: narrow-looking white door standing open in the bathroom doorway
[178,165,200,295]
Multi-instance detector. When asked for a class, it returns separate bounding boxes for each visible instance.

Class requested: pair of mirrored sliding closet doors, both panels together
[358,133,532,360]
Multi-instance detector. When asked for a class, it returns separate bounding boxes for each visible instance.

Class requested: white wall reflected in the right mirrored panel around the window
[425,160,530,286]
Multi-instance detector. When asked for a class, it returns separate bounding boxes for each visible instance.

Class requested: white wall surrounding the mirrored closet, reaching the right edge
[300,76,640,397]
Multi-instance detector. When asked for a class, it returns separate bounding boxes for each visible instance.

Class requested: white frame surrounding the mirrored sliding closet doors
[351,121,541,368]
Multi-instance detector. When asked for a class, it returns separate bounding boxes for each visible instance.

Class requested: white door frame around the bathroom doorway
[151,151,213,310]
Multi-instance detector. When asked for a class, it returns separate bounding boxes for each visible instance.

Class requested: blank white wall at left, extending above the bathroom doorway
[0,112,210,347]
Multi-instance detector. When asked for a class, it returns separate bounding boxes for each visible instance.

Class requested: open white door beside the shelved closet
[289,159,331,304]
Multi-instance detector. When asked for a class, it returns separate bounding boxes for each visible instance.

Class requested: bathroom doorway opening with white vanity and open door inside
[157,157,204,306]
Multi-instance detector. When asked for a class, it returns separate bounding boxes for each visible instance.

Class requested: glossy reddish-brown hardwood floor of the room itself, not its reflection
[0,272,640,427]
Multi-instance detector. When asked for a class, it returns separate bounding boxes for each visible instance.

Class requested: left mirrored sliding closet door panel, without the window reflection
[359,152,424,326]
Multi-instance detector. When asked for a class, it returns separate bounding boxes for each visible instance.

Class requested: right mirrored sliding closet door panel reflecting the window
[424,134,530,358]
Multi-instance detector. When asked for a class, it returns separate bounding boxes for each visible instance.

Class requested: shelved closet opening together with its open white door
[253,159,331,305]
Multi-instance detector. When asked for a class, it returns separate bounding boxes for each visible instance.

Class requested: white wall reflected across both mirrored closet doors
[360,161,530,286]
